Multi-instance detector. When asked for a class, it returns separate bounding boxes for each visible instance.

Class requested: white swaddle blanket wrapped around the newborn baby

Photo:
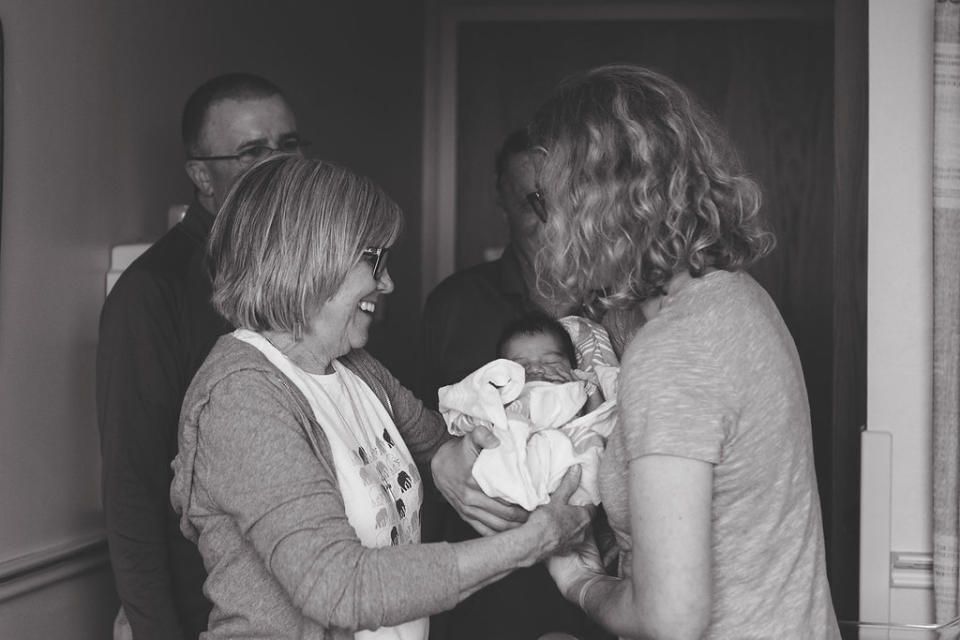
[439,359,619,510]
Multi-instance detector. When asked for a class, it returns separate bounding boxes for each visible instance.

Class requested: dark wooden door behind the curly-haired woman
[455,0,866,620]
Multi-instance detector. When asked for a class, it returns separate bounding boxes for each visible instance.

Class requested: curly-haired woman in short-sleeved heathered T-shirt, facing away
[530,65,840,640]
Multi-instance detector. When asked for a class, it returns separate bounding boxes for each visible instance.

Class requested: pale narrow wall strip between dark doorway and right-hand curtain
[861,0,934,622]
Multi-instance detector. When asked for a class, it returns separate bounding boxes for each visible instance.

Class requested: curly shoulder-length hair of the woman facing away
[529,65,775,308]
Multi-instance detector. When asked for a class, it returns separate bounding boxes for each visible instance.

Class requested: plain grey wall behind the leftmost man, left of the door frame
[0,0,423,638]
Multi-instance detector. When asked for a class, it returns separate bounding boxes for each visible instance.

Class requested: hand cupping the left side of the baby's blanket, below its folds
[430,426,529,536]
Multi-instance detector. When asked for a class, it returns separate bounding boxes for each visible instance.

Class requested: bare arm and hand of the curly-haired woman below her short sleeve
[551,455,713,639]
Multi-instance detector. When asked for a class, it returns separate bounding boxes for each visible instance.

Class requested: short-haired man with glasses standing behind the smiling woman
[97,73,305,640]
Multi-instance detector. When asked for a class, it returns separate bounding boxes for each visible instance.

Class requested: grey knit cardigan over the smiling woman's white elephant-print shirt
[170,335,460,640]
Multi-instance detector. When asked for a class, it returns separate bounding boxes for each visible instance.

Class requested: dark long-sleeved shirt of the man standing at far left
[97,202,231,640]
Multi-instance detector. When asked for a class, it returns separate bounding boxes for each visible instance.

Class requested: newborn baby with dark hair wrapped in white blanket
[439,314,619,510]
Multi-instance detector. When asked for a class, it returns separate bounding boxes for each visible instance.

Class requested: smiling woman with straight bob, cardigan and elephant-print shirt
[171,156,589,640]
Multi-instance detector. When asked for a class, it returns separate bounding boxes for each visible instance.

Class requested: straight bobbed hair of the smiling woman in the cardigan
[207,154,403,337]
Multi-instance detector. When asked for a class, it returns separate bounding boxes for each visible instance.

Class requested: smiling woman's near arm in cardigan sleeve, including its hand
[187,372,589,629]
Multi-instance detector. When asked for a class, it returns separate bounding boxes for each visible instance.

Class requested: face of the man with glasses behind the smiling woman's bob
[196,96,299,214]
